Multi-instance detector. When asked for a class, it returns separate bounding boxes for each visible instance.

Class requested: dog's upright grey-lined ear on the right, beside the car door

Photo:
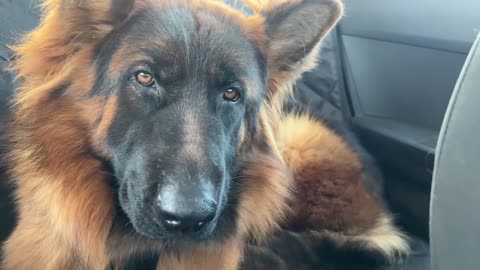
[262,0,343,89]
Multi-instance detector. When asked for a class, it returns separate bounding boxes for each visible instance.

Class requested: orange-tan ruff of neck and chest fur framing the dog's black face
[2,0,290,270]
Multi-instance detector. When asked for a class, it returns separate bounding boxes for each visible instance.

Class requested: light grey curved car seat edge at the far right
[430,35,480,270]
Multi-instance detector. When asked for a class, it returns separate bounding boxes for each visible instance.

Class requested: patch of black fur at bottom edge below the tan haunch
[240,231,388,270]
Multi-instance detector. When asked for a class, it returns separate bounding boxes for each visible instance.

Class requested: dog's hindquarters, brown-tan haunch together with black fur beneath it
[241,110,410,270]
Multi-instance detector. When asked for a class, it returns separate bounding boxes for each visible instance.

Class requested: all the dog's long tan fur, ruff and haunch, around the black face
[1,0,406,270]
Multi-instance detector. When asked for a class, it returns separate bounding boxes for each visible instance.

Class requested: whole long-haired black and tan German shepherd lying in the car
[1,0,408,270]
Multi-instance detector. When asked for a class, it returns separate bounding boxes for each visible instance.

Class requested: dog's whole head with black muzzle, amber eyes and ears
[13,0,341,239]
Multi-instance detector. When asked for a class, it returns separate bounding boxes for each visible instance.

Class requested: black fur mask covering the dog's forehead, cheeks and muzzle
[91,3,266,240]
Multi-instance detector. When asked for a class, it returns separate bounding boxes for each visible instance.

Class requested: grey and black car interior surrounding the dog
[0,0,480,270]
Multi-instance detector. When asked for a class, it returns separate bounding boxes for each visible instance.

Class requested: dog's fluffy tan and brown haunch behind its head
[276,114,409,259]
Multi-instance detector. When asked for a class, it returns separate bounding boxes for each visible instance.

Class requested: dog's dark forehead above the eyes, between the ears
[106,4,262,83]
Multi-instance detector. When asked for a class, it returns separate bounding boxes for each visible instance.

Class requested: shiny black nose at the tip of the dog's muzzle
[155,197,217,233]
